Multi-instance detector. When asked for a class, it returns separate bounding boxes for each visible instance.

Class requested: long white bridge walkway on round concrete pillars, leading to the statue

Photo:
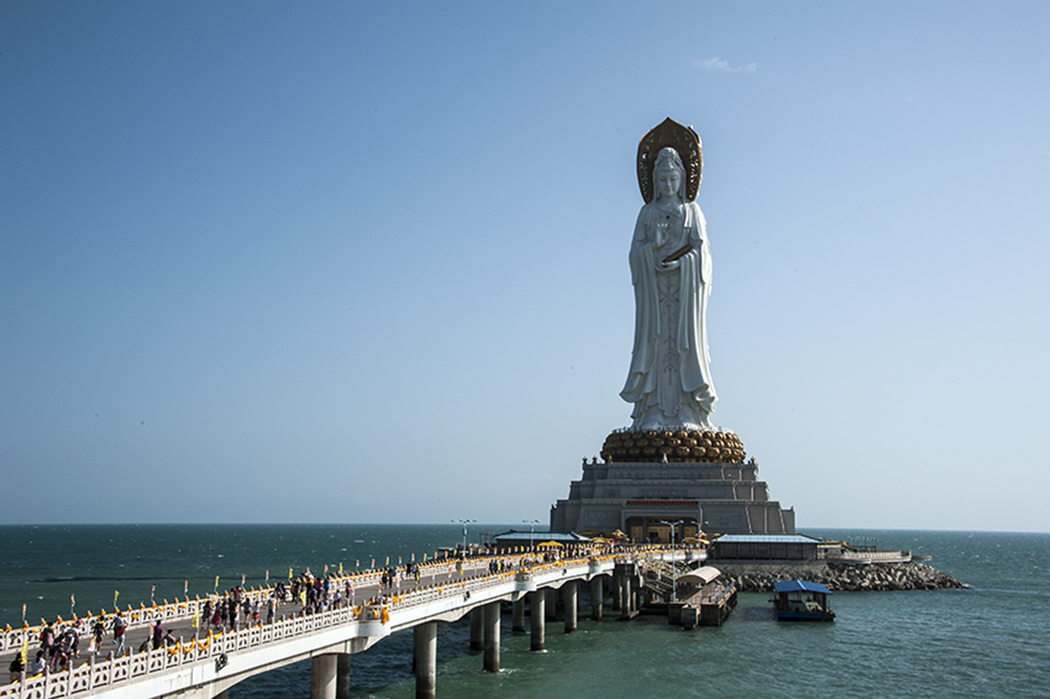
[0,546,700,699]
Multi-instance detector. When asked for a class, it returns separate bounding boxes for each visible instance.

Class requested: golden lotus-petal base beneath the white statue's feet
[602,429,748,464]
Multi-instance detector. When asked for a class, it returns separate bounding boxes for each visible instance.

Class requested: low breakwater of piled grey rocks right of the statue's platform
[711,562,966,592]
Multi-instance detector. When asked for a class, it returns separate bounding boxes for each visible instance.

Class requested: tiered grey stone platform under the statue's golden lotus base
[550,454,795,535]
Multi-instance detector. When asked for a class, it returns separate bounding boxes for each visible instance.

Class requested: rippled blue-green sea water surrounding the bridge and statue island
[0,525,1050,699]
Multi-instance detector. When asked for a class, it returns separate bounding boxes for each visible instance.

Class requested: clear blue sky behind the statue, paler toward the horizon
[0,1,1050,531]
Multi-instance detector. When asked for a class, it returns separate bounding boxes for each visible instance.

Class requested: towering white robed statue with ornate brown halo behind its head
[620,125,717,430]
